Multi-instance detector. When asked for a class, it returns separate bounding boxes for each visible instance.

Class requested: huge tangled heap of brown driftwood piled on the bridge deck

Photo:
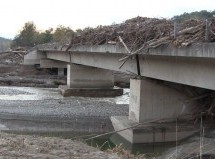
[66,17,215,50]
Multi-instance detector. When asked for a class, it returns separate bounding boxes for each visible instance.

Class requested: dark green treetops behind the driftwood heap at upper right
[172,10,215,22]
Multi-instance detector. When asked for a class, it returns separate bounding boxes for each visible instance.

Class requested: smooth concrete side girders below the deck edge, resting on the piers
[47,52,215,90]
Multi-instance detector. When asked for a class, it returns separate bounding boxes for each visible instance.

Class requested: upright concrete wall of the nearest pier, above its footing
[129,78,193,122]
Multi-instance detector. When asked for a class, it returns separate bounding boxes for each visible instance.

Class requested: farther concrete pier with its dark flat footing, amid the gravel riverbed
[59,64,123,97]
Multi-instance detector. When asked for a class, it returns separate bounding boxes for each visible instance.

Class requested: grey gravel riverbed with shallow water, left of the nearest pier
[0,87,128,133]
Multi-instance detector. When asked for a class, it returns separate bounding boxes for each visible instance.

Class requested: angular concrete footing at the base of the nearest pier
[111,116,199,144]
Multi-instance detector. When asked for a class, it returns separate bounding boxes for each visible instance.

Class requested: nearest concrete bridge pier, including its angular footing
[111,78,196,143]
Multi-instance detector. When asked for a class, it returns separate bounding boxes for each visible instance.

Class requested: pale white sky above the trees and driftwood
[0,0,215,39]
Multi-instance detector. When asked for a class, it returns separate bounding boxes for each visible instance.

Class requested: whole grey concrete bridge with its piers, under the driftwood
[23,43,215,143]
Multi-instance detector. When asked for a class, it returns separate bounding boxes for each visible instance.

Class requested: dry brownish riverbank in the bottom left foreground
[0,132,121,159]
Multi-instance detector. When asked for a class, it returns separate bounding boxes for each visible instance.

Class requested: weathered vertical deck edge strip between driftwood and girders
[40,43,215,58]
